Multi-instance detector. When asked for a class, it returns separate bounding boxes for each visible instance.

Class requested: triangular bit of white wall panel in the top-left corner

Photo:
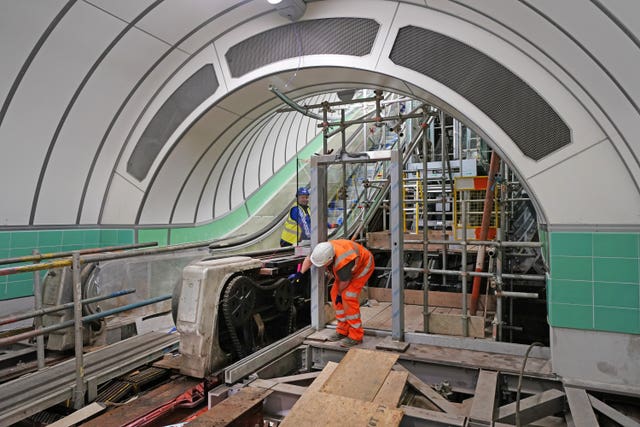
[0,0,66,113]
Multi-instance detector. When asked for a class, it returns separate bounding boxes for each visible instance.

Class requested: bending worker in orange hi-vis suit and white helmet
[289,239,374,347]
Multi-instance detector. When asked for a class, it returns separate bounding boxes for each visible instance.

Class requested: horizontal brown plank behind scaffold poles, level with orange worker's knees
[368,288,496,311]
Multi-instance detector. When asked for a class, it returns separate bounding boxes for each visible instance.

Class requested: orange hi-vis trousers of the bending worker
[331,268,373,341]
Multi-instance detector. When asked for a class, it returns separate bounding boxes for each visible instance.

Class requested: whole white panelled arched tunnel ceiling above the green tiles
[0,0,640,231]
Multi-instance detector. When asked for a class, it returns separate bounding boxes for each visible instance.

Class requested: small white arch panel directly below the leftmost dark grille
[102,175,144,225]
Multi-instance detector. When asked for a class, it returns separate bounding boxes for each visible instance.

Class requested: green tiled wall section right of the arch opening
[547,232,640,334]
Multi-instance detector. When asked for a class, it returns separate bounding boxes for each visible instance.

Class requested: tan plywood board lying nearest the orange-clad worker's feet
[321,348,398,402]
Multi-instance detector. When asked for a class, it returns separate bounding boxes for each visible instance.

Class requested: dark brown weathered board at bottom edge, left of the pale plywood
[189,387,271,427]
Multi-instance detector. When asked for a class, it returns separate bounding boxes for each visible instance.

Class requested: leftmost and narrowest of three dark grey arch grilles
[127,64,218,181]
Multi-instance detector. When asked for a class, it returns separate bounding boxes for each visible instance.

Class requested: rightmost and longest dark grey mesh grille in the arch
[389,26,571,160]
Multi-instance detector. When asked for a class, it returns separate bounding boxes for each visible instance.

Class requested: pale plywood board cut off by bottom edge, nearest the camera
[280,392,403,427]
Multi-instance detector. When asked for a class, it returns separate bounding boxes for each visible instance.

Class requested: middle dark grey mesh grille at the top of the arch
[225,18,380,77]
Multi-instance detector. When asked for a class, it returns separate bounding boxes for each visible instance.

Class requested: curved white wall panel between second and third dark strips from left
[35,28,166,224]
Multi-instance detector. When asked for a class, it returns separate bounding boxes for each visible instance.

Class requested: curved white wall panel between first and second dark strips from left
[0,2,125,224]
